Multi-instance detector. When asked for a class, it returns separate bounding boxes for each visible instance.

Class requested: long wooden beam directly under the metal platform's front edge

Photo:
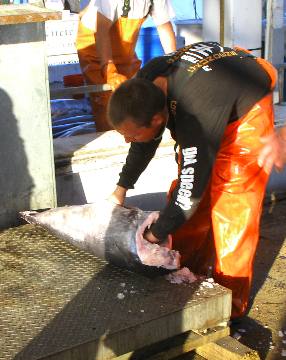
[115,327,229,360]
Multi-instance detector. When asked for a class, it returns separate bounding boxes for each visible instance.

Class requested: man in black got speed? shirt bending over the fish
[108,42,276,318]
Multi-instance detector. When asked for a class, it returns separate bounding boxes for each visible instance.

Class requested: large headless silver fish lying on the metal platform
[20,200,180,275]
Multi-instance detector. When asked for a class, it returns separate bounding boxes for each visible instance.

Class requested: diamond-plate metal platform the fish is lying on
[0,225,231,360]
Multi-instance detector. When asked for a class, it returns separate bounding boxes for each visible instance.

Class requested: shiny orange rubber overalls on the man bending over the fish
[169,50,276,318]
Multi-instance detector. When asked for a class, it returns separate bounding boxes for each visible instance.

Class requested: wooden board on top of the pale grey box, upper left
[0,4,62,25]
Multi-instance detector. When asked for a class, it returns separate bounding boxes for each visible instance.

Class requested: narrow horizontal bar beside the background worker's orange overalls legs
[50,84,111,99]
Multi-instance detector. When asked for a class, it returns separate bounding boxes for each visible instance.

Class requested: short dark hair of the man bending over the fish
[107,78,166,127]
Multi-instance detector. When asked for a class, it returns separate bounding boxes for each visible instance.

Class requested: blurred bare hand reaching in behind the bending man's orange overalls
[258,126,286,174]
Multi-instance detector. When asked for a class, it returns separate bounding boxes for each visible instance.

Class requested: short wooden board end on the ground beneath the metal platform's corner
[195,336,260,360]
